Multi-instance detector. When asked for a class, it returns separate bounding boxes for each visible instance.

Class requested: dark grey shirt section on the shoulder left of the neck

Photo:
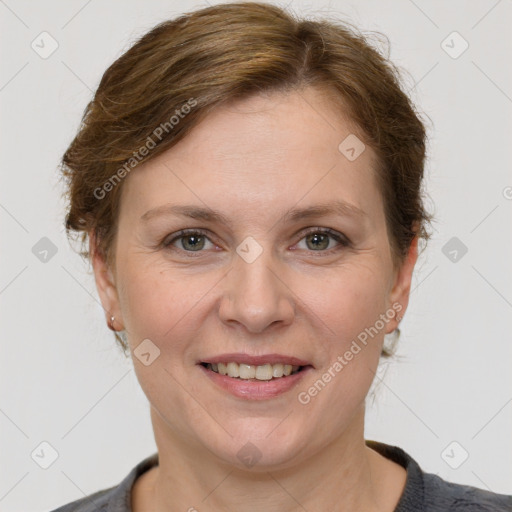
[51,453,158,512]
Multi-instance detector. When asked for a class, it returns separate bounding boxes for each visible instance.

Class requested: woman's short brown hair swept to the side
[61,2,431,355]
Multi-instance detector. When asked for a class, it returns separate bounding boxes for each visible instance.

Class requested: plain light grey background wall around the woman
[0,0,512,512]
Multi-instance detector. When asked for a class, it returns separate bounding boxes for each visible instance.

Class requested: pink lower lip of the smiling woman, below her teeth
[198,365,312,400]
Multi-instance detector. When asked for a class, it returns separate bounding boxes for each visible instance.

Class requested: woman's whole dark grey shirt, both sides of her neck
[52,440,512,512]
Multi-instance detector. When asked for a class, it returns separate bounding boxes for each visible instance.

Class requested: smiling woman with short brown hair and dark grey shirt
[52,3,512,512]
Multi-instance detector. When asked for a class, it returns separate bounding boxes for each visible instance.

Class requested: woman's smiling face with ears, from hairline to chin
[94,89,417,467]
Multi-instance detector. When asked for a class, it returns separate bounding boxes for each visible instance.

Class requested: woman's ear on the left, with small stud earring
[89,230,124,331]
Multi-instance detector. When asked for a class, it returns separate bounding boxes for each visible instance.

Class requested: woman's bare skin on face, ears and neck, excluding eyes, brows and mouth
[90,88,417,512]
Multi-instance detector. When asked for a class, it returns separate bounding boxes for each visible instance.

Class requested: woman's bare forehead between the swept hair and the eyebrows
[121,89,381,222]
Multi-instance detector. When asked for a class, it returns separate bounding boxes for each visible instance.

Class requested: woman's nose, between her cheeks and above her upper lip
[219,249,295,333]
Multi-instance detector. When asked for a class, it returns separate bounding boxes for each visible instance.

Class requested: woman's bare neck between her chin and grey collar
[142,404,405,512]
